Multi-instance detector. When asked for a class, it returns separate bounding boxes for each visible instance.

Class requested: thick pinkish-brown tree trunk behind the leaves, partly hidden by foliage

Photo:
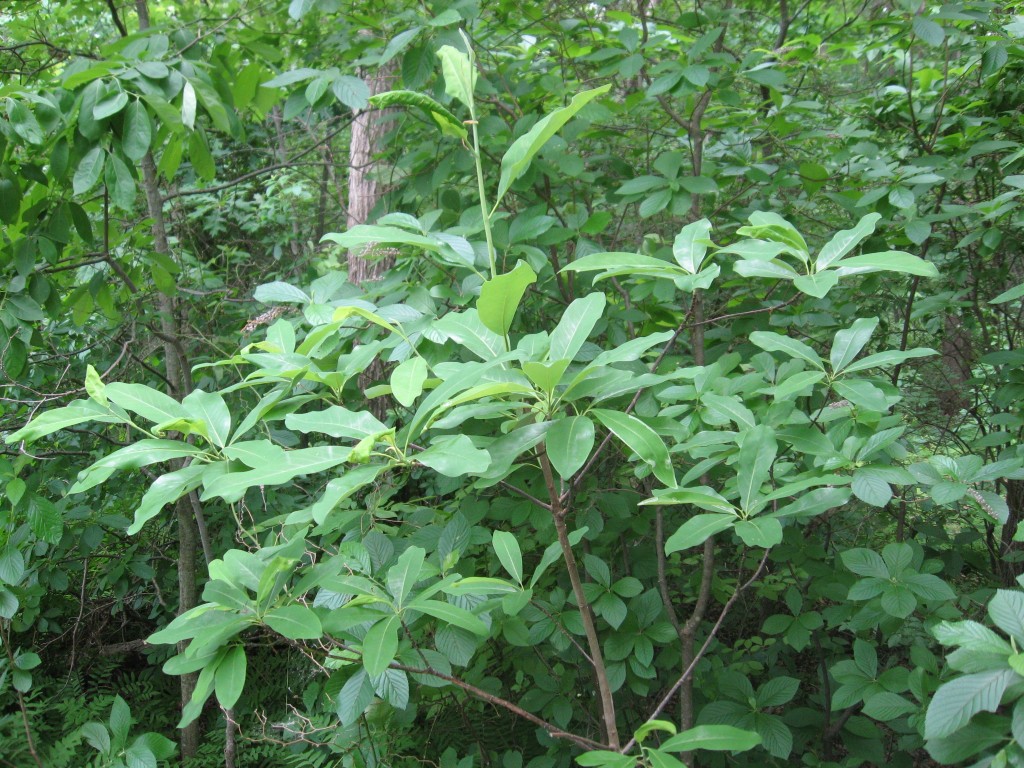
[347,59,396,286]
